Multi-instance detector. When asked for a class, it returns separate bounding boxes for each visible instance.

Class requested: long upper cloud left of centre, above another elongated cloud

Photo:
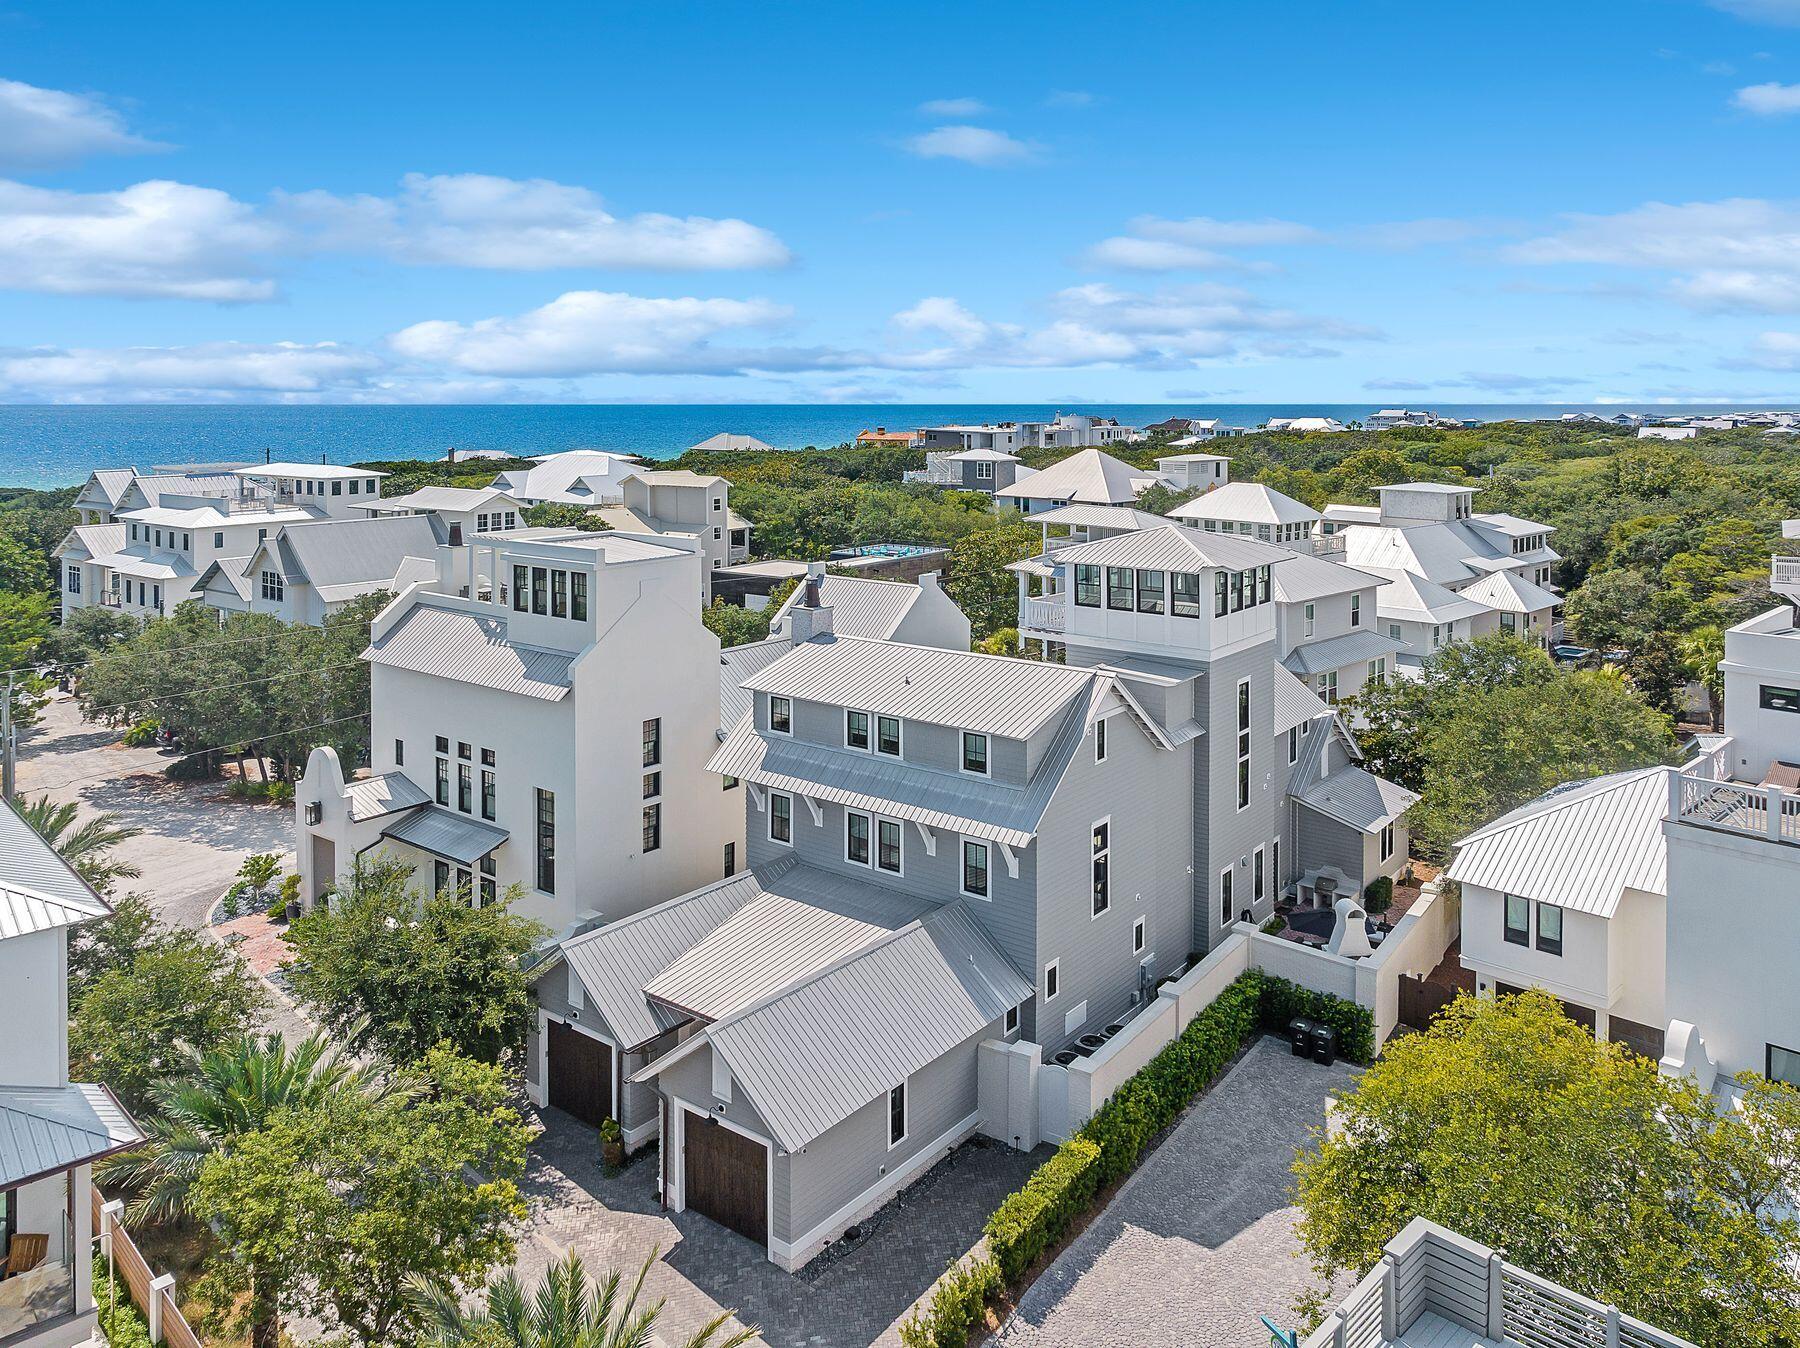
[275,173,788,272]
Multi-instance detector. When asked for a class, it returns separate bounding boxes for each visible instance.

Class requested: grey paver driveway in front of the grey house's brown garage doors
[518,1109,1049,1348]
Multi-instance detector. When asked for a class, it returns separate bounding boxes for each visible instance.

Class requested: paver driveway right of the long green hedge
[995,1038,1354,1348]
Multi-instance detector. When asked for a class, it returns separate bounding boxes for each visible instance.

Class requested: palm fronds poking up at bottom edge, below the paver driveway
[418,1249,756,1348]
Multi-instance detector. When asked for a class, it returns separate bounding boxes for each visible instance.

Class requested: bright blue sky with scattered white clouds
[0,0,1800,405]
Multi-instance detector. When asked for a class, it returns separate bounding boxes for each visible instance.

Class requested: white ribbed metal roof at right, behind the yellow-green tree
[1445,767,1674,918]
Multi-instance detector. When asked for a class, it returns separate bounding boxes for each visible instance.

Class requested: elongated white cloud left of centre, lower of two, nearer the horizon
[389,290,803,378]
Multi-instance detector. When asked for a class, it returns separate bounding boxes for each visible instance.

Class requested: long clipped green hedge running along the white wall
[900,968,1375,1348]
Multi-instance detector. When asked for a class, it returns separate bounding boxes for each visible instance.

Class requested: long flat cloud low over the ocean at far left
[0,342,382,401]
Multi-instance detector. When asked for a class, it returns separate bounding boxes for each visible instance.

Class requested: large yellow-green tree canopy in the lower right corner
[1294,992,1800,1344]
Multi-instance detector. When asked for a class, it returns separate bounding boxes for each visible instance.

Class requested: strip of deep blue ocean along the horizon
[0,403,1778,488]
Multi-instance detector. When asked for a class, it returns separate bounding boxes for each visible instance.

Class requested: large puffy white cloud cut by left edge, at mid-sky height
[0,180,283,302]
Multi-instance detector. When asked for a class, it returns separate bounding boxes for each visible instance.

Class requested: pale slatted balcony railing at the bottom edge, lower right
[1305,1217,1694,1348]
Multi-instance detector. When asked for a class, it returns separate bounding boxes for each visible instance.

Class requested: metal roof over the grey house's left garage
[562,857,777,1047]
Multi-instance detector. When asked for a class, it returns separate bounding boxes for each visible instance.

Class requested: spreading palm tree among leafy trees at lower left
[95,1031,391,1226]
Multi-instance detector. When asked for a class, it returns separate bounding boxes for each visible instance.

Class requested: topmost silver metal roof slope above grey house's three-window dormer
[745,635,1093,740]
